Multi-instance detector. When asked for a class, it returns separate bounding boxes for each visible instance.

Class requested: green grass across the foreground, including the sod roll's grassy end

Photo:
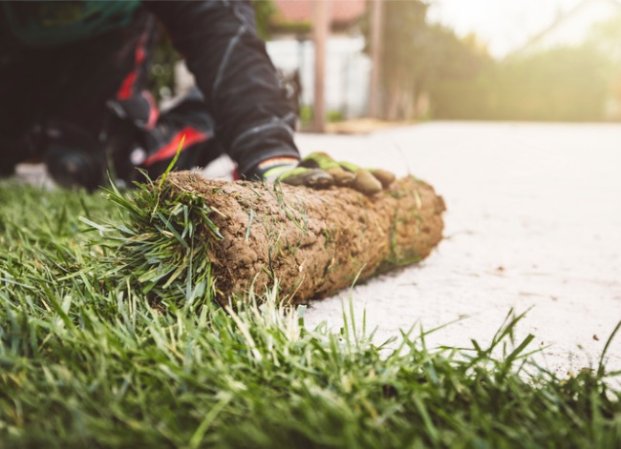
[0,179,621,449]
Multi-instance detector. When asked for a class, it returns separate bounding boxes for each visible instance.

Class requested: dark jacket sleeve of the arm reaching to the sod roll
[144,0,299,174]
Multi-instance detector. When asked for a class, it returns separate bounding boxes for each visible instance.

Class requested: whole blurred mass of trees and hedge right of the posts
[366,1,621,121]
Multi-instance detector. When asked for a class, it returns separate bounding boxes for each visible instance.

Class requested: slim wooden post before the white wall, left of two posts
[313,0,330,132]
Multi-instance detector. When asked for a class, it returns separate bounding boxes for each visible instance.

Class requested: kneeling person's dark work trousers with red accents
[0,12,221,188]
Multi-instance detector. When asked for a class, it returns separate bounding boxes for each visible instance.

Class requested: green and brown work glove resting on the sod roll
[262,152,395,195]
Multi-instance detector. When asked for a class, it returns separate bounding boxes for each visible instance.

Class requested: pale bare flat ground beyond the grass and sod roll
[298,122,621,371]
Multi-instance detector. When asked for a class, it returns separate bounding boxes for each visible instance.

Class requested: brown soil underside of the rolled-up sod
[167,172,445,303]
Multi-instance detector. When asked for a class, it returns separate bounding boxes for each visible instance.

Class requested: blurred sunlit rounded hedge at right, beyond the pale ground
[431,45,608,121]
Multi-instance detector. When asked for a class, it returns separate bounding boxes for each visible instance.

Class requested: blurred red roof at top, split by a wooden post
[275,0,366,24]
